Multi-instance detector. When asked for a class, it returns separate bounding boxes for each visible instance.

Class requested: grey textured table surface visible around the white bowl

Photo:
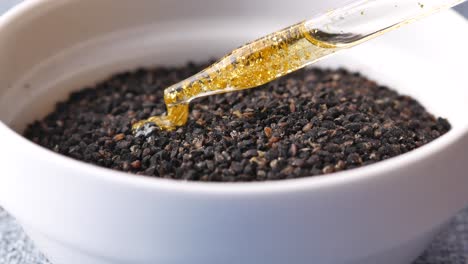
[0,0,468,264]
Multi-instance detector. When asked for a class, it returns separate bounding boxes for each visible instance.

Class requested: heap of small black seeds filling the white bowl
[25,64,450,182]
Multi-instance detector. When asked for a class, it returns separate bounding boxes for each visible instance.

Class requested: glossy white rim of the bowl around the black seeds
[0,0,468,195]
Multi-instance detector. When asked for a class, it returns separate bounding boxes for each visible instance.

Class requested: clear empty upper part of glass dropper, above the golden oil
[305,0,465,47]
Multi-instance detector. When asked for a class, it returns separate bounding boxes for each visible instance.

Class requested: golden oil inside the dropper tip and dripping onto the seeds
[133,23,340,130]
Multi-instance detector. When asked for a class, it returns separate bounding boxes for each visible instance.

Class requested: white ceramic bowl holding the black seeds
[0,0,468,264]
